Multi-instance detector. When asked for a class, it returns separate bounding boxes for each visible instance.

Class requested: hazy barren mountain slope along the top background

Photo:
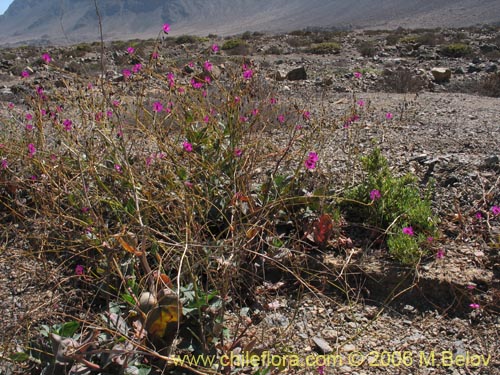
[0,0,500,44]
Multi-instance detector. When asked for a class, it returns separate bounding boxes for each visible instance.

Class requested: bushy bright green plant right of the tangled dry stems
[347,148,437,265]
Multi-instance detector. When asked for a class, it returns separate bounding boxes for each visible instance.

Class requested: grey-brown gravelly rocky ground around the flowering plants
[0,29,500,375]
